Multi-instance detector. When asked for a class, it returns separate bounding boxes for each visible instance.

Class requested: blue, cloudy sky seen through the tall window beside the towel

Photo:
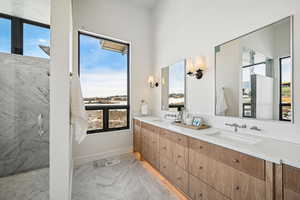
[80,34,127,97]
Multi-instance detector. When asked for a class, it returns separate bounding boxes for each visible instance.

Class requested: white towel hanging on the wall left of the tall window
[71,74,88,143]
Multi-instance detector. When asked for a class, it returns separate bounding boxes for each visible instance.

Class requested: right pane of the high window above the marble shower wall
[23,23,50,58]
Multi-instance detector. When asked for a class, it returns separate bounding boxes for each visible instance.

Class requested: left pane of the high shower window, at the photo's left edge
[0,17,11,53]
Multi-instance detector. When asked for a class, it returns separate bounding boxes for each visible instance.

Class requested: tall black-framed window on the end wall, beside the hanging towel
[79,33,130,133]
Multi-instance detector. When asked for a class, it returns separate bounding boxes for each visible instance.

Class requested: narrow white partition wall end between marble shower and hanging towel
[50,0,72,200]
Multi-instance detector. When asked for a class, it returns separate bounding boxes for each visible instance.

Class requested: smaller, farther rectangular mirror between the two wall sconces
[161,60,186,111]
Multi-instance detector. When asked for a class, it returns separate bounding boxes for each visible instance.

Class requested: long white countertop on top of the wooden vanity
[134,117,300,168]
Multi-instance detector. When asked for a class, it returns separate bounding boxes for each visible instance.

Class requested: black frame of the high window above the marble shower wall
[0,13,50,55]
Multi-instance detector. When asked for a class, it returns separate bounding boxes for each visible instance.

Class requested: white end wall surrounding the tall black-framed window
[73,0,153,163]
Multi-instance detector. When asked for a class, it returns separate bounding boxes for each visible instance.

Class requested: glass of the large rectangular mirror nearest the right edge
[215,17,293,122]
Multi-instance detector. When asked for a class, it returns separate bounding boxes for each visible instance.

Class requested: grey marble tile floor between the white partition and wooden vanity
[72,154,181,200]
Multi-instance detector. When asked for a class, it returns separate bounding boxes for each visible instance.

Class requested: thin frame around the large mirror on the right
[214,15,295,124]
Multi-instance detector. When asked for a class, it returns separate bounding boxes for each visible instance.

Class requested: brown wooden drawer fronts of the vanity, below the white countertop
[137,122,276,200]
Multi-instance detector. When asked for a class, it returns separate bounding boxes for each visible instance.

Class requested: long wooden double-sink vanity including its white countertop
[133,117,300,200]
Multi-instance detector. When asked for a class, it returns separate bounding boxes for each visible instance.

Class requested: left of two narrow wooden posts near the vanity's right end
[266,161,275,200]
